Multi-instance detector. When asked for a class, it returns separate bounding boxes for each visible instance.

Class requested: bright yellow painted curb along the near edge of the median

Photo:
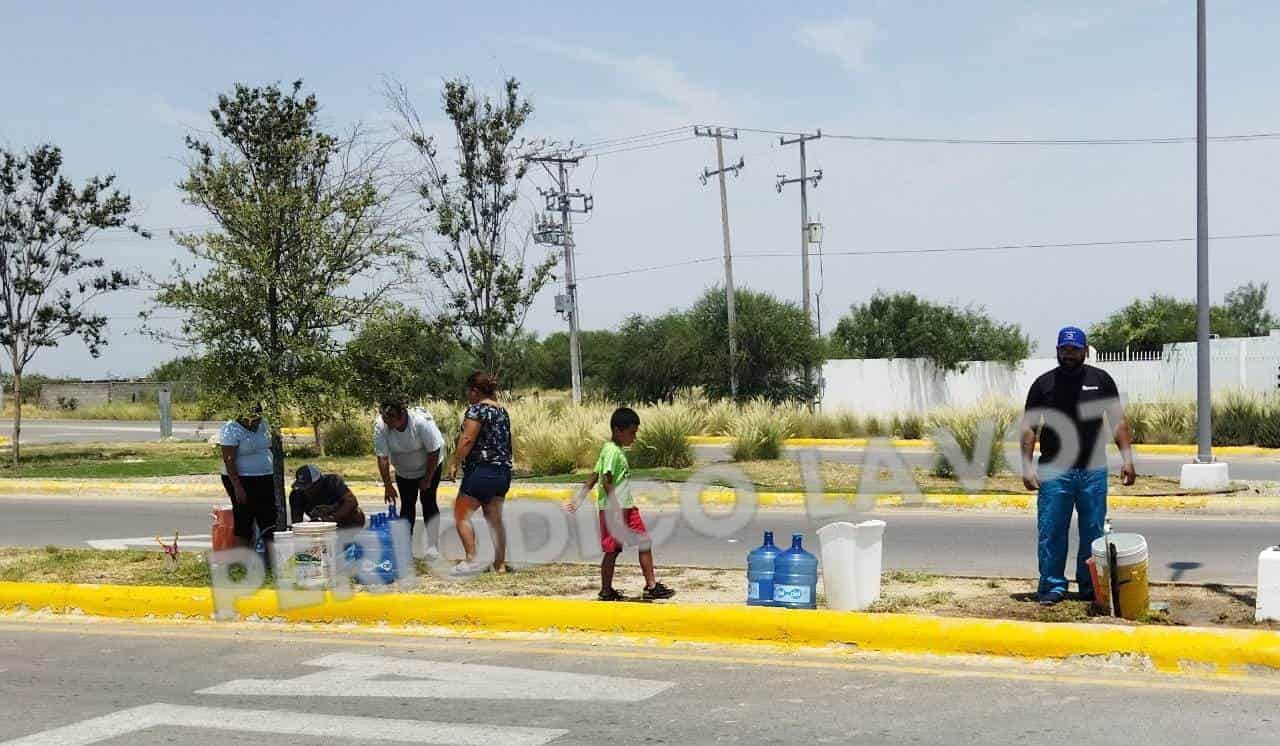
[0,582,1280,673]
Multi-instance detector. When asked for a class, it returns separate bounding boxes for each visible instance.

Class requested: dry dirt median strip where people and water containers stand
[0,548,1280,630]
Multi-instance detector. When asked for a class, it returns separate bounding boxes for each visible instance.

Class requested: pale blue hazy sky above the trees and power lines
[0,0,1280,377]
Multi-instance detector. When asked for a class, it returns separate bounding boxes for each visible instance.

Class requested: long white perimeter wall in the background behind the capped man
[822,331,1280,415]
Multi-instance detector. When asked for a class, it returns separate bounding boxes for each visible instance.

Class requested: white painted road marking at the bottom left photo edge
[0,702,568,746]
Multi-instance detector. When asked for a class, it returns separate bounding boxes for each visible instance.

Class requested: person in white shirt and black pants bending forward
[374,398,444,559]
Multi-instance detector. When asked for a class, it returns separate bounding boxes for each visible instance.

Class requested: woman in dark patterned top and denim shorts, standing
[449,371,511,575]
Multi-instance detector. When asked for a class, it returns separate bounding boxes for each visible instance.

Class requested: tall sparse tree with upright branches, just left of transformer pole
[387,78,556,375]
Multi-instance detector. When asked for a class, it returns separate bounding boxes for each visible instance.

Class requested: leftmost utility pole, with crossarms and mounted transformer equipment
[529,155,595,406]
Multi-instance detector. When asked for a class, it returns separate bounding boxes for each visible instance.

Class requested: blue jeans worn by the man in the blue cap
[1036,468,1107,596]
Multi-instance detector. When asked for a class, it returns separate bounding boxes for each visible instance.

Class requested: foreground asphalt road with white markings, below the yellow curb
[0,621,1277,746]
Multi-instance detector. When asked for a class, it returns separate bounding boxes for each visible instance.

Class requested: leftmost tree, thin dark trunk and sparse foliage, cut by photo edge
[0,145,150,463]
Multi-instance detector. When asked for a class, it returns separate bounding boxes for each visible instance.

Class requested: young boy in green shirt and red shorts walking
[564,407,676,601]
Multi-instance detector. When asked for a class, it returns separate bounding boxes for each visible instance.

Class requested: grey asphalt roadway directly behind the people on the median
[0,496,1280,585]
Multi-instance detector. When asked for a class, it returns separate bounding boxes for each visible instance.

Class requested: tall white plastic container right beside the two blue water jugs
[818,521,884,612]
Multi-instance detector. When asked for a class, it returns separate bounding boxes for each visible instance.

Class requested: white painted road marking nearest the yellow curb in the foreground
[196,653,675,702]
